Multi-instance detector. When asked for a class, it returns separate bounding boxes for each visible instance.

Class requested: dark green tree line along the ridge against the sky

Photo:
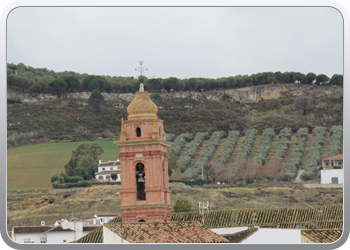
[7,63,343,97]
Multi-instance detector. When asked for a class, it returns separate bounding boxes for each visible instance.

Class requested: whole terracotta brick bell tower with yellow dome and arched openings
[115,78,171,222]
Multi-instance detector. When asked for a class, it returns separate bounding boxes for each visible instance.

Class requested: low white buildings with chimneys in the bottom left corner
[11,218,101,243]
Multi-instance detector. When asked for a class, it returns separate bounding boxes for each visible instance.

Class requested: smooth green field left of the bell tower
[7,141,119,191]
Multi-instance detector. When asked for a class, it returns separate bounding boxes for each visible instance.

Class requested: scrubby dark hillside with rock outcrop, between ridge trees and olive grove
[7,84,343,140]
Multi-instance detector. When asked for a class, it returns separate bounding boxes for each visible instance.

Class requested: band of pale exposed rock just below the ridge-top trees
[7,84,334,104]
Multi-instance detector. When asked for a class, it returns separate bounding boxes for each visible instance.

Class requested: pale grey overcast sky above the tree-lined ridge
[7,7,343,79]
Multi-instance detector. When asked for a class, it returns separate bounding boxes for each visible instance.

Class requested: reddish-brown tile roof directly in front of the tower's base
[104,221,229,243]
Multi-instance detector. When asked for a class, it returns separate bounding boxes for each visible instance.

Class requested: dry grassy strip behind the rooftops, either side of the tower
[7,183,343,230]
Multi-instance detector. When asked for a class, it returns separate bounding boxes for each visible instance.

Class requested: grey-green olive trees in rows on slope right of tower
[169,126,343,183]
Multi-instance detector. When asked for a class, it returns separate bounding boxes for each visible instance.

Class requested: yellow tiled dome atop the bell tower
[127,92,158,120]
